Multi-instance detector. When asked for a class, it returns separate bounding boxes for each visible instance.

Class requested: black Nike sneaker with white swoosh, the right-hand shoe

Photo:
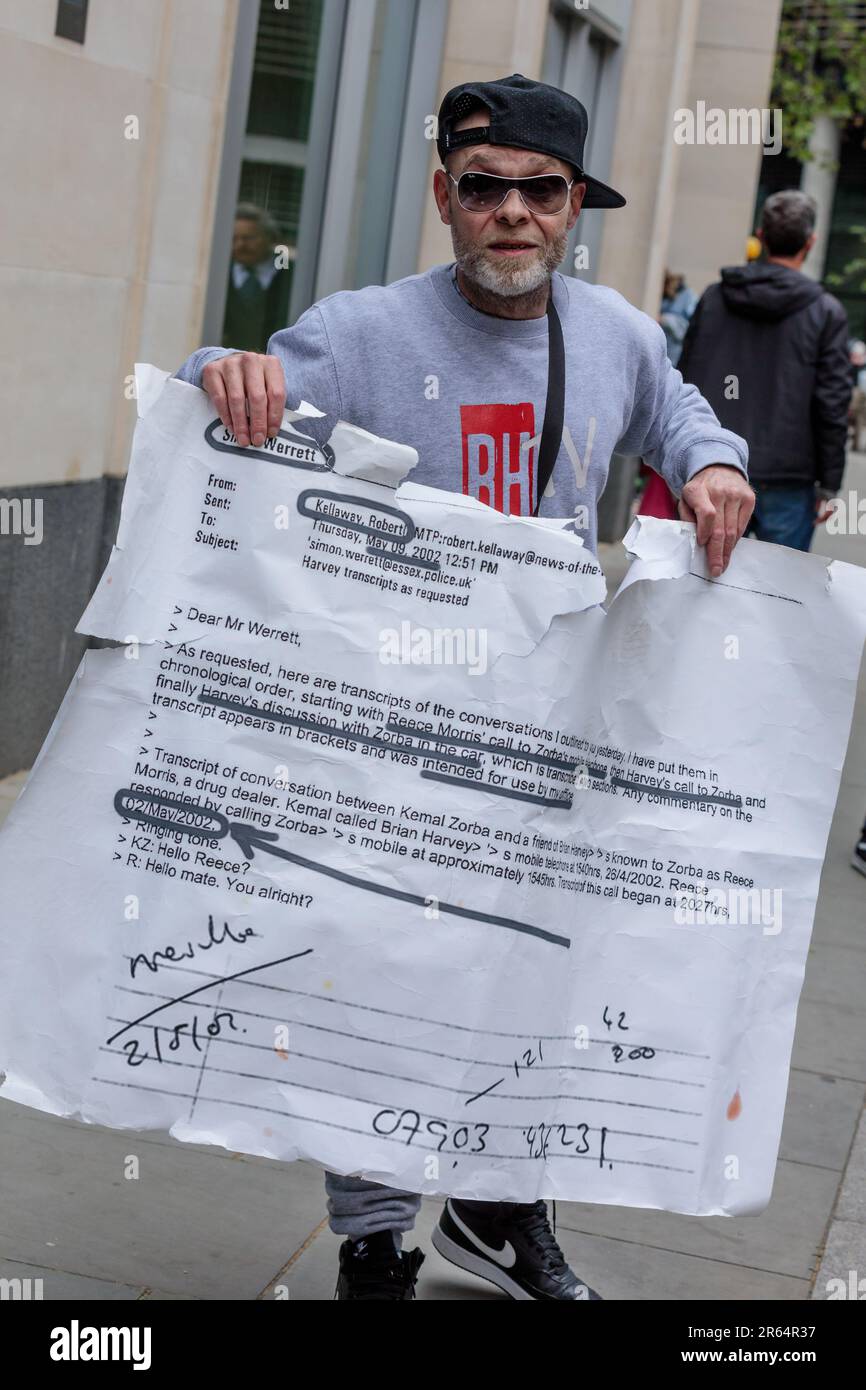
[432,1197,602,1302]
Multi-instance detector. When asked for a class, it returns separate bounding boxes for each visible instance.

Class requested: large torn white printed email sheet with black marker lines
[0,371,866,1213]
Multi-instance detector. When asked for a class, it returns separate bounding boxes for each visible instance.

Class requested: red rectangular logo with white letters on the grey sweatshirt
[460,400,535,516]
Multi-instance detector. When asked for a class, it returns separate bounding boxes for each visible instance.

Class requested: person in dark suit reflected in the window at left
[222,203,292,352]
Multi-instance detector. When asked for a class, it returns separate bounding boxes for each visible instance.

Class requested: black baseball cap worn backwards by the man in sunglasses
[436,72,626,207]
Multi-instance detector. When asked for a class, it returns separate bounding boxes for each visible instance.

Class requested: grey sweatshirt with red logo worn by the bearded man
[177,265,748,549]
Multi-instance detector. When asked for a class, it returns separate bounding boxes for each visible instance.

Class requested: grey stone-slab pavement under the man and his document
[0,455,866,1301]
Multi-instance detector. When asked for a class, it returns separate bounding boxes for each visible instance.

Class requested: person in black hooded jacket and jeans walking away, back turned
[680,189,851,550]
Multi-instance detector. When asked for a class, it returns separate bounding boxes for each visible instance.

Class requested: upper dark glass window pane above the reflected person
[246,0,322,142]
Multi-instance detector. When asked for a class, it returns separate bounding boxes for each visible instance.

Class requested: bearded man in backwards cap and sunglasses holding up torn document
[179,75,753,1298]
